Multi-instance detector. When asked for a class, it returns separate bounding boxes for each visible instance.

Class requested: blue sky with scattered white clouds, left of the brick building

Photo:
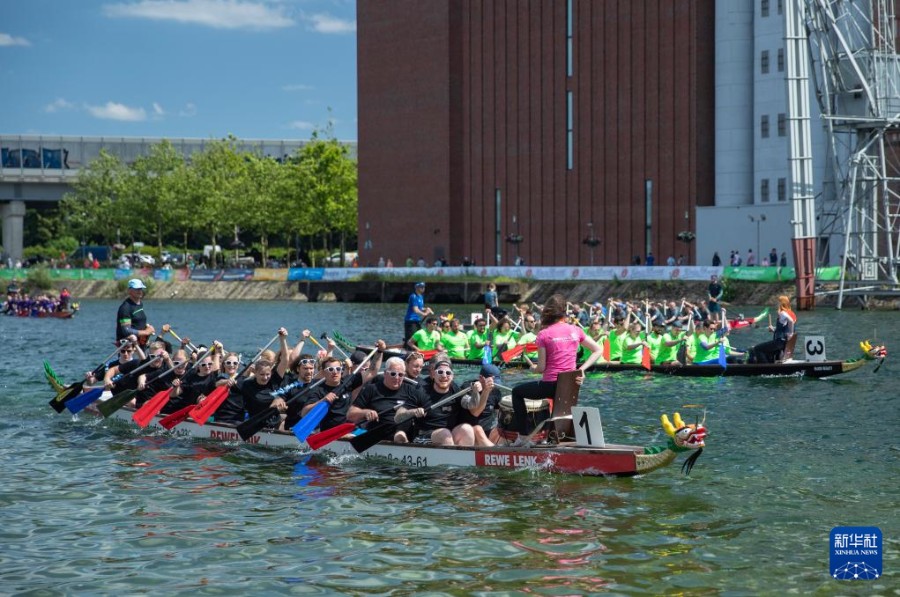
[0,0,357,140]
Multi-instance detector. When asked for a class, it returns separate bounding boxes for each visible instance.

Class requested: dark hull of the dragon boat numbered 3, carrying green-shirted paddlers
[358,346,867,378]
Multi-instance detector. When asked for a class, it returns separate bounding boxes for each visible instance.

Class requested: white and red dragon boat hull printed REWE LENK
[95,400,674,477]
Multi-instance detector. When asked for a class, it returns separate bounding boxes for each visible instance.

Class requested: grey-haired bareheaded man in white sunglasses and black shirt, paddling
[347,357,428,443]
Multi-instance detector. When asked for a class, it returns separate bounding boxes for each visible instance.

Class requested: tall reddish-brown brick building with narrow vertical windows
[357,0,715,265]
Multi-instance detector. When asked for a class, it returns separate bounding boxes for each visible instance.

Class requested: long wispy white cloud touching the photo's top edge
[103,0,294,30]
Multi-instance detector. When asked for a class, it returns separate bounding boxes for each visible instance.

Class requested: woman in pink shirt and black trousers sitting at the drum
[512,294,603,445]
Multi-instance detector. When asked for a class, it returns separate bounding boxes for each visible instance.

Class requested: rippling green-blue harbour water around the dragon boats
[0,301,900,595]
